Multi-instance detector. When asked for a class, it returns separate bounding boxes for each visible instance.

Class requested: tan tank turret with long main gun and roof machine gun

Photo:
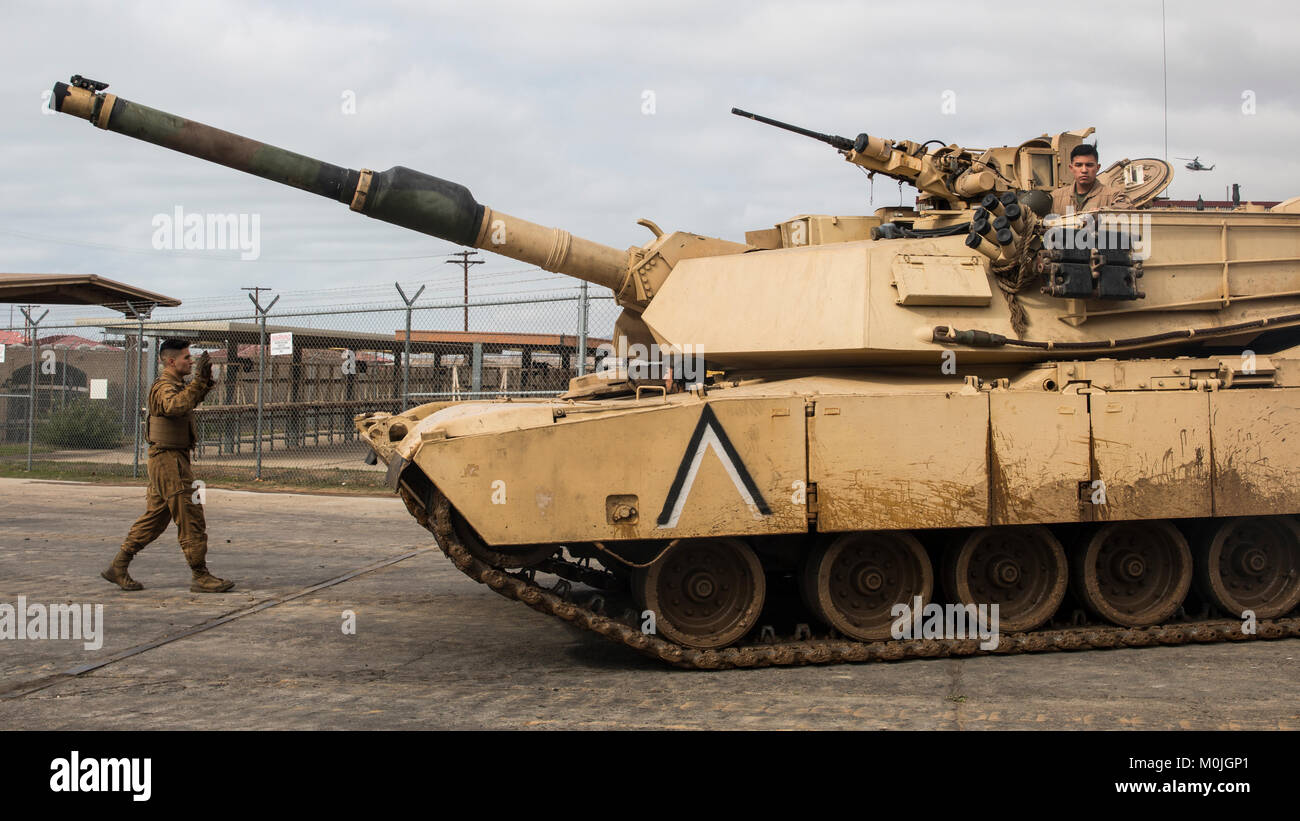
[53,75,1300,369]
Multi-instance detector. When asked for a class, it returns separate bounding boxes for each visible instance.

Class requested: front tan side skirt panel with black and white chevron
[415,395,807,544]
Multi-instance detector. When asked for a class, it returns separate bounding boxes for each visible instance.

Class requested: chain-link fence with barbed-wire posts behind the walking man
[0,287,619,487]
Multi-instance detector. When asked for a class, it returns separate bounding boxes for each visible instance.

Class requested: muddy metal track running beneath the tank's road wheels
[400,487,1300,670]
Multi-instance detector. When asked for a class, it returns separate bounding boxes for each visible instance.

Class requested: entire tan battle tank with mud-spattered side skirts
[53,78,1300,668]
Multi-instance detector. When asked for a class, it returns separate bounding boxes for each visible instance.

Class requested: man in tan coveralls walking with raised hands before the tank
[100,339,235,592]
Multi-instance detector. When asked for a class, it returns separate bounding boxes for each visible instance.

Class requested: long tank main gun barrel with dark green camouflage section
[52,75,628,291]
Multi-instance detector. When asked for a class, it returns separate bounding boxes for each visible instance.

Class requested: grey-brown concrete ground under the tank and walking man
[0,479,1300,730]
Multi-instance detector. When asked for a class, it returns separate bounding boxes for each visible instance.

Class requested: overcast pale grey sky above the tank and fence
[0,0,1300,329]
